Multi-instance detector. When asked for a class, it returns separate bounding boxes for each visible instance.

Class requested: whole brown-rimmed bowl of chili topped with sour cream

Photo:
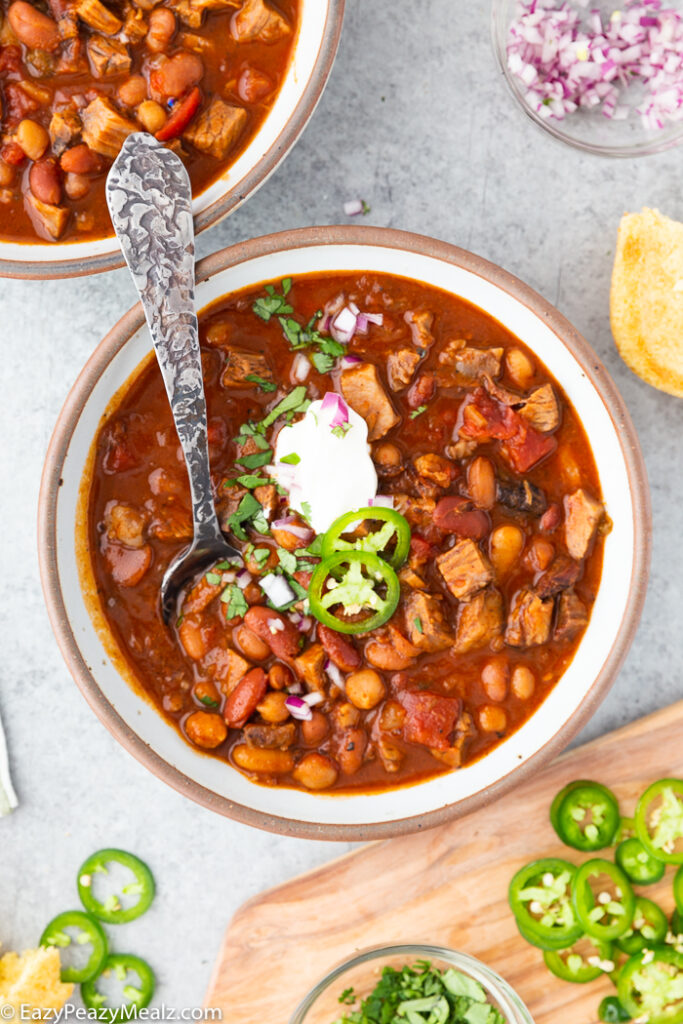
[40,227,649,839]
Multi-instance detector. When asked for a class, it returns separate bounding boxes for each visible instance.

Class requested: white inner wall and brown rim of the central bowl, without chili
[39,227,650,840]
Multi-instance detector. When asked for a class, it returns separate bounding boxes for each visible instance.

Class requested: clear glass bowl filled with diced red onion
[493,0,683,157]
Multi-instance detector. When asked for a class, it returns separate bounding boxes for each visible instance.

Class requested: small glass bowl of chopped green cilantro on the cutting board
[290,945,533,1024]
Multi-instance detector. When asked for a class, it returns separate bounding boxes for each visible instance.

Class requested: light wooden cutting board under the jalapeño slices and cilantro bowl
[206,701,683,1024]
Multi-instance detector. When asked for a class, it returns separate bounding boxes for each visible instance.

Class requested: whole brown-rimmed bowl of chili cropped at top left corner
[0,0,344,278]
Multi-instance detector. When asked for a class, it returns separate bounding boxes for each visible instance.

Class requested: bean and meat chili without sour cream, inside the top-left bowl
[0,0,299,242]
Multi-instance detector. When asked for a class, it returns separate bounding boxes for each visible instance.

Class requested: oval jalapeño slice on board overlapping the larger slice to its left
[572,857,636,942]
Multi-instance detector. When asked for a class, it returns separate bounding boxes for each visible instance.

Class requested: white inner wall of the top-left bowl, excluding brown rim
[0,0,330,263]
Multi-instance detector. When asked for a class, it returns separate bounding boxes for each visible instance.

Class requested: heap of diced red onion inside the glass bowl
[507,0,683,130]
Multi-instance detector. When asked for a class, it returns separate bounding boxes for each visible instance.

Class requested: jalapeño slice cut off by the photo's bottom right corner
[616,946,683,1024]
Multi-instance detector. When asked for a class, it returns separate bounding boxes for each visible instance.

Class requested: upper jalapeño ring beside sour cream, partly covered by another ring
[321,506,411,569]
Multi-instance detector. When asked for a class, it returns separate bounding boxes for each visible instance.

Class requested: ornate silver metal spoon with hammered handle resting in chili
[106,132,240,625]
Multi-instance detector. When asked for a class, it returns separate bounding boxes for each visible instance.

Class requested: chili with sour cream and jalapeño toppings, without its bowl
[88,273,609,791]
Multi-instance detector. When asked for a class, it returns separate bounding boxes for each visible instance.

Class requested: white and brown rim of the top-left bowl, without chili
[0,0,345,279]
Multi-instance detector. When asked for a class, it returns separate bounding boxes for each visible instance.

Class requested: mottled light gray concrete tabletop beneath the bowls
[0,0,683,1008]
